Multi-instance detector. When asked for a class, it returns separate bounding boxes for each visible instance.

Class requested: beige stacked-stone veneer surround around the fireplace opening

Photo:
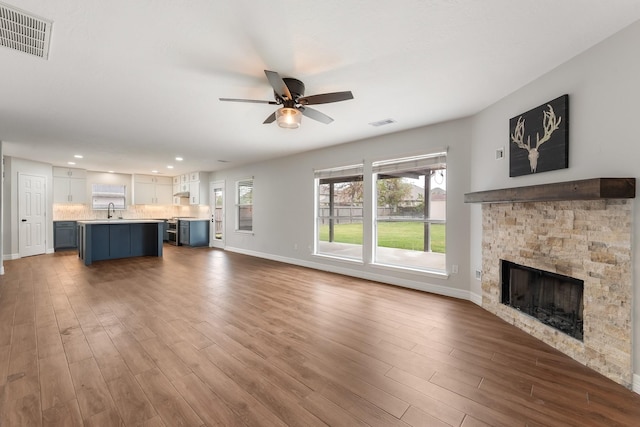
[482,199,633,388]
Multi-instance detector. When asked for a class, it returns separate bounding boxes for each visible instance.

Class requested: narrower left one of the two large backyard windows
[314,165,363,260]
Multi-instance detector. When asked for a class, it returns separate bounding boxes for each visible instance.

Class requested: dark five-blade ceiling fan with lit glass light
[219,70,353,129]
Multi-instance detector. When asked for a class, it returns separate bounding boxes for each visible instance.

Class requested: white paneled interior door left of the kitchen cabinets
[18,174,46,257]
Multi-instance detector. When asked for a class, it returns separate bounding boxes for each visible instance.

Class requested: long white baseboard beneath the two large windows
[225,246,472,301]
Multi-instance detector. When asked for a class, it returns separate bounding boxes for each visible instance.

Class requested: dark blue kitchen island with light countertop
[78,219,164,265]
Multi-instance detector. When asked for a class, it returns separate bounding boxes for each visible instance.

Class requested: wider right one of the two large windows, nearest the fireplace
[372,153,447,272]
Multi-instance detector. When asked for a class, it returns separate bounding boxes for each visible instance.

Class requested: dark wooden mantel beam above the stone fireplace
[464,178,636,203]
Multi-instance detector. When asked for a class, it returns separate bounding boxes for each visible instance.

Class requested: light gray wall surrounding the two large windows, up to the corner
[211,120,470,299]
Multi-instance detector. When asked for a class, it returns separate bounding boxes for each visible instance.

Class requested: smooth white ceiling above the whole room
[0,0,640,175]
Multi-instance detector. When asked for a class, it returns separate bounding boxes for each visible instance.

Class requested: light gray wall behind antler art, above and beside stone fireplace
[470,22,640,384]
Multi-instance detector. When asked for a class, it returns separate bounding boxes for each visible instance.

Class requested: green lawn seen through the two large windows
[320,222,445,253]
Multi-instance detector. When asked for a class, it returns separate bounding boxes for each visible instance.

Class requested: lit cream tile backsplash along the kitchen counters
[53,203,209,221]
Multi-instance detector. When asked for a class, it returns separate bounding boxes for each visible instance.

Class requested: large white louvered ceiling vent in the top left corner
[0,3,53,59]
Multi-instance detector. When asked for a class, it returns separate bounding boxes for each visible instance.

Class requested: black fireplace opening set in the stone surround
[500,260,584,341]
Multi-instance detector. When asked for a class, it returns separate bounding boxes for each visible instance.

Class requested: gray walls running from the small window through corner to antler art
[212,22,640,390]
